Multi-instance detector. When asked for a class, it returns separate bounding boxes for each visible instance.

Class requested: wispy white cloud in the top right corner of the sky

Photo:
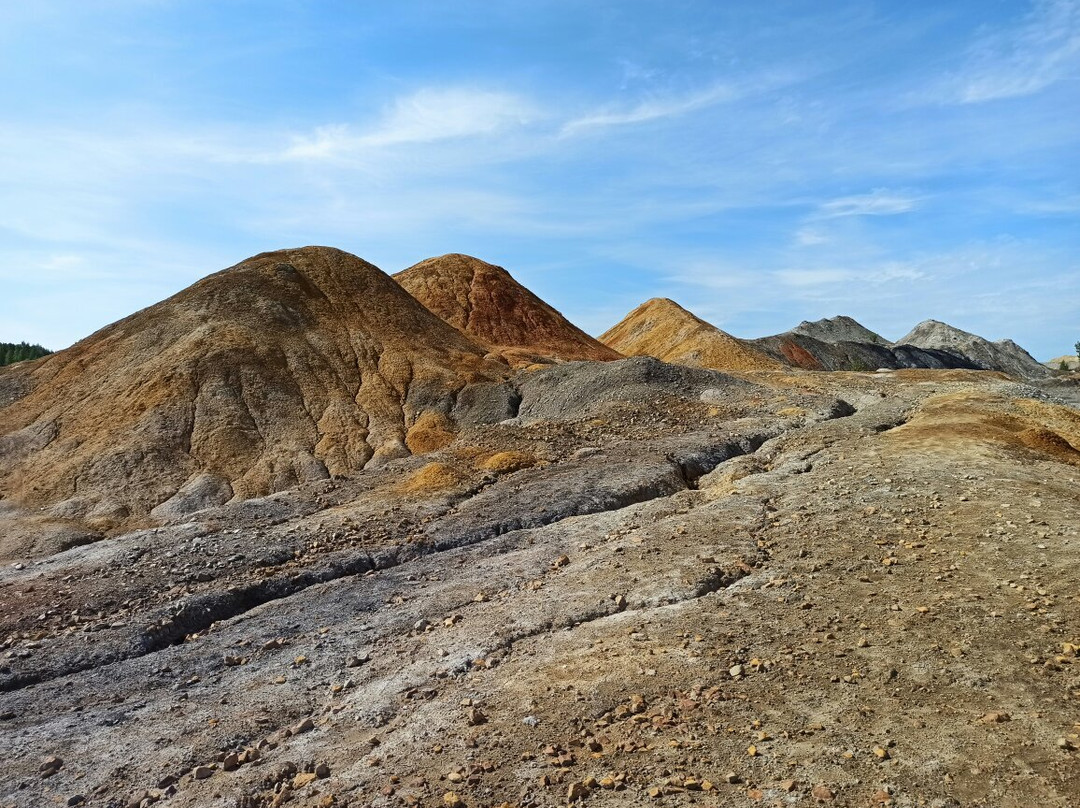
[940,0,1080,104]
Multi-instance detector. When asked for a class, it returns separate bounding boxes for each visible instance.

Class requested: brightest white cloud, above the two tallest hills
[280,87,538,160]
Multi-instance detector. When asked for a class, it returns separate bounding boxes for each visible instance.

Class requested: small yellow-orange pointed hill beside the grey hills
[600,297,784,371]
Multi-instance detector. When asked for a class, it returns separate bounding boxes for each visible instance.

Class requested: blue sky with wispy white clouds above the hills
[0,0,1080,360]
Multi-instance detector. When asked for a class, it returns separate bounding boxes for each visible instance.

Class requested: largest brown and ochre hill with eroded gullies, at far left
[0,247,505,548]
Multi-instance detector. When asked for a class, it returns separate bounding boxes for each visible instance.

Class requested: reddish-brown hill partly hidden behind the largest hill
[394,253,621,365]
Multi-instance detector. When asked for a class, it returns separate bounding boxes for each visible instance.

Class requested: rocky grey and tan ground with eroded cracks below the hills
[0,359,1080,808]
